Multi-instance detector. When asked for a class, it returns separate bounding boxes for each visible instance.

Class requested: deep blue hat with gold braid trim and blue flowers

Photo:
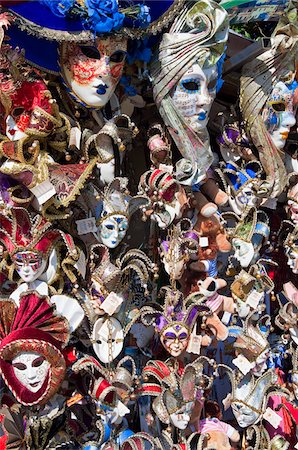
[1,0,177,74]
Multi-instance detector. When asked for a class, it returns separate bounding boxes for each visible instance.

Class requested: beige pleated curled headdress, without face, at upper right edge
[240,1,298,197]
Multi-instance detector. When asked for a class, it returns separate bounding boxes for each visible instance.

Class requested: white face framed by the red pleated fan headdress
[11,352,50,393]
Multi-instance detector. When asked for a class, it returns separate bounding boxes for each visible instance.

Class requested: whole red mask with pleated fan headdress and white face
[0,292,69,406]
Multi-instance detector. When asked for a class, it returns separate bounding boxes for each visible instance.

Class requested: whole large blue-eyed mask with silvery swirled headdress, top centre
[152,0,228,169]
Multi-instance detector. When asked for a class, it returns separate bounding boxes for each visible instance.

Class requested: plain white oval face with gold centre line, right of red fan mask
[92,317,124,363]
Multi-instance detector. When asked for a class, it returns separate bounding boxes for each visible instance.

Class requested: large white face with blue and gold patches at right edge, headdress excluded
[262,81,297,150]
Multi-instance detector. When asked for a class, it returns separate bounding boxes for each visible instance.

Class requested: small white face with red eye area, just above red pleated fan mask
[13,251,47,283]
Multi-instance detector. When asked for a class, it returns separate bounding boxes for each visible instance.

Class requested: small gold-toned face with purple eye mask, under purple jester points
[160,323,189,357]
